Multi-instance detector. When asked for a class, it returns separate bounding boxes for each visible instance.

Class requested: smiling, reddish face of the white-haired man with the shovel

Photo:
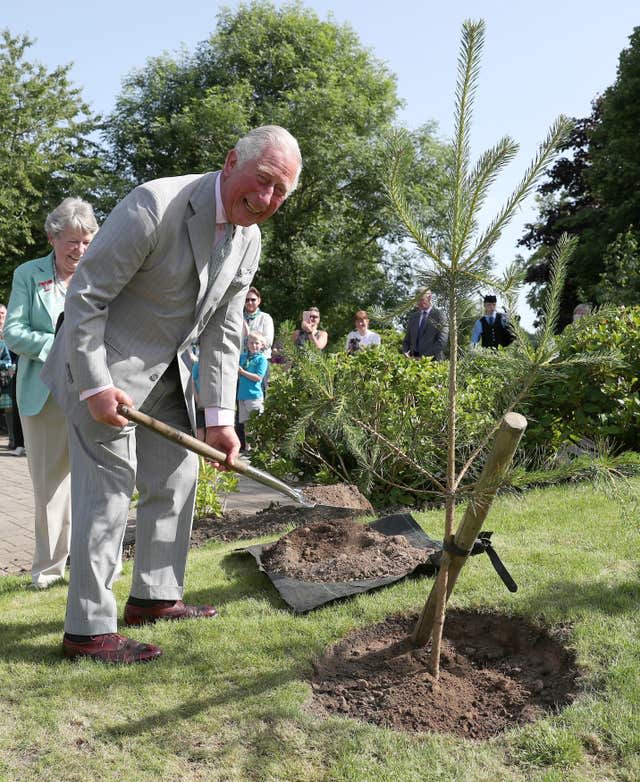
[220,145,298,228]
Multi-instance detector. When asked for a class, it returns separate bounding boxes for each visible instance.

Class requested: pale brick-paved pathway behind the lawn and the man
[0,435,292,576]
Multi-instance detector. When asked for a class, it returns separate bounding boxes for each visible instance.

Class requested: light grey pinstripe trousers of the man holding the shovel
[65,361,198,635]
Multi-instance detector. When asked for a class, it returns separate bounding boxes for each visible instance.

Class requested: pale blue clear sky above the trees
[6,0,640,325]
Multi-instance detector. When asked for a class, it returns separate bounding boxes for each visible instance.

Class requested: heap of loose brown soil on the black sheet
[262,517,435,583]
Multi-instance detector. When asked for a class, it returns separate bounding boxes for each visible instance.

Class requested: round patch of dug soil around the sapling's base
[311,610,580,739]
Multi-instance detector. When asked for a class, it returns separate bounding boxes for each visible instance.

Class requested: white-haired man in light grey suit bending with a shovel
[42,126,302,663]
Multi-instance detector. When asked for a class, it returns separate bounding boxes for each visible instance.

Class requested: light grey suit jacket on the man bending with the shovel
[42,173,260,426]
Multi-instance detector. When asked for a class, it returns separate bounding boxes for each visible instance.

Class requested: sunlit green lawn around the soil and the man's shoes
[0,481,640,782]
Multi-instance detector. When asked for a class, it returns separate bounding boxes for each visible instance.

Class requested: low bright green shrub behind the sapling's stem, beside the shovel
[250,345,501,505]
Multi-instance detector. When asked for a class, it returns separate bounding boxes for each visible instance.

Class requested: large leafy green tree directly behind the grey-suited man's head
[100,0,448,335]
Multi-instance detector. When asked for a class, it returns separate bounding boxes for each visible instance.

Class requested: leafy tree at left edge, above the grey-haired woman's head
[0,30,98,300]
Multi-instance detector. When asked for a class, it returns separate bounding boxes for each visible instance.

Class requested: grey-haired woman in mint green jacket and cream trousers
[4,198,98,589]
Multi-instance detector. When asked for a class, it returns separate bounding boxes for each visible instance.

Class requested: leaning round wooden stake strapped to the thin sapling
[413,413,527,646]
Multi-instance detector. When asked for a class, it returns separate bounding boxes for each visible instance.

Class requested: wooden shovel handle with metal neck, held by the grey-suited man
[118,404,316,508]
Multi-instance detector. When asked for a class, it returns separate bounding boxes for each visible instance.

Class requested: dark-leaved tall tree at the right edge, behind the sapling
[520,27,640,326]
